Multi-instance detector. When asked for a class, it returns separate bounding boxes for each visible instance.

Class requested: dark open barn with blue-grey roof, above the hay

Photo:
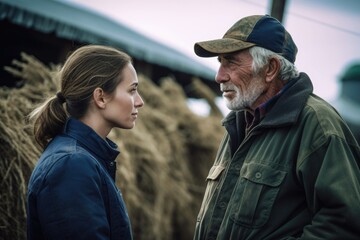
[0,0,220,95]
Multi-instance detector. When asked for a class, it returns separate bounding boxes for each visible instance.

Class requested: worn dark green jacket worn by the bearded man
[194,73,360,240]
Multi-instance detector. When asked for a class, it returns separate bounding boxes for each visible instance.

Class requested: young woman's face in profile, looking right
[103,63,144,129]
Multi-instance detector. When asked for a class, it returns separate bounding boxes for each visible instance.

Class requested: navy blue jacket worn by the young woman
[27,118,132,240]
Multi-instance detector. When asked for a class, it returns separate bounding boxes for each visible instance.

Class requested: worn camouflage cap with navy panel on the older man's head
[194,15,297,63]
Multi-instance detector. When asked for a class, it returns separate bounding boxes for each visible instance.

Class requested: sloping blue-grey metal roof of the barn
[0,0,215,80]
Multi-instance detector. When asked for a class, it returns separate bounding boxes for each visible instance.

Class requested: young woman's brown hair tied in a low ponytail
[30,45,132,148]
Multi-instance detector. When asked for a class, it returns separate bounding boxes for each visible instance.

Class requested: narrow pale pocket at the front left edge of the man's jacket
[197,165,225,221]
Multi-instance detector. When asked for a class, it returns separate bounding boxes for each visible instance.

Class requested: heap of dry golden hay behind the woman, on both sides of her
[0,54,223,240]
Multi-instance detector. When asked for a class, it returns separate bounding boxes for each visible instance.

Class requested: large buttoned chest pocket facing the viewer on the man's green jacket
[230,163,286,228]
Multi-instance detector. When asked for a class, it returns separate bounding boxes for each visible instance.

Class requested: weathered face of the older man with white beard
[215,50,266,110]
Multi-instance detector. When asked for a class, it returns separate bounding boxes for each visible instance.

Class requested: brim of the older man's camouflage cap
[194,38,256,57]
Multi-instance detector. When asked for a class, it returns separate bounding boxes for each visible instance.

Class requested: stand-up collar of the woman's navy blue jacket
[64,117,120,165]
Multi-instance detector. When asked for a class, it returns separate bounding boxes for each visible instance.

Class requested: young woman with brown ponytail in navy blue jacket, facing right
[27,45,144,240]
